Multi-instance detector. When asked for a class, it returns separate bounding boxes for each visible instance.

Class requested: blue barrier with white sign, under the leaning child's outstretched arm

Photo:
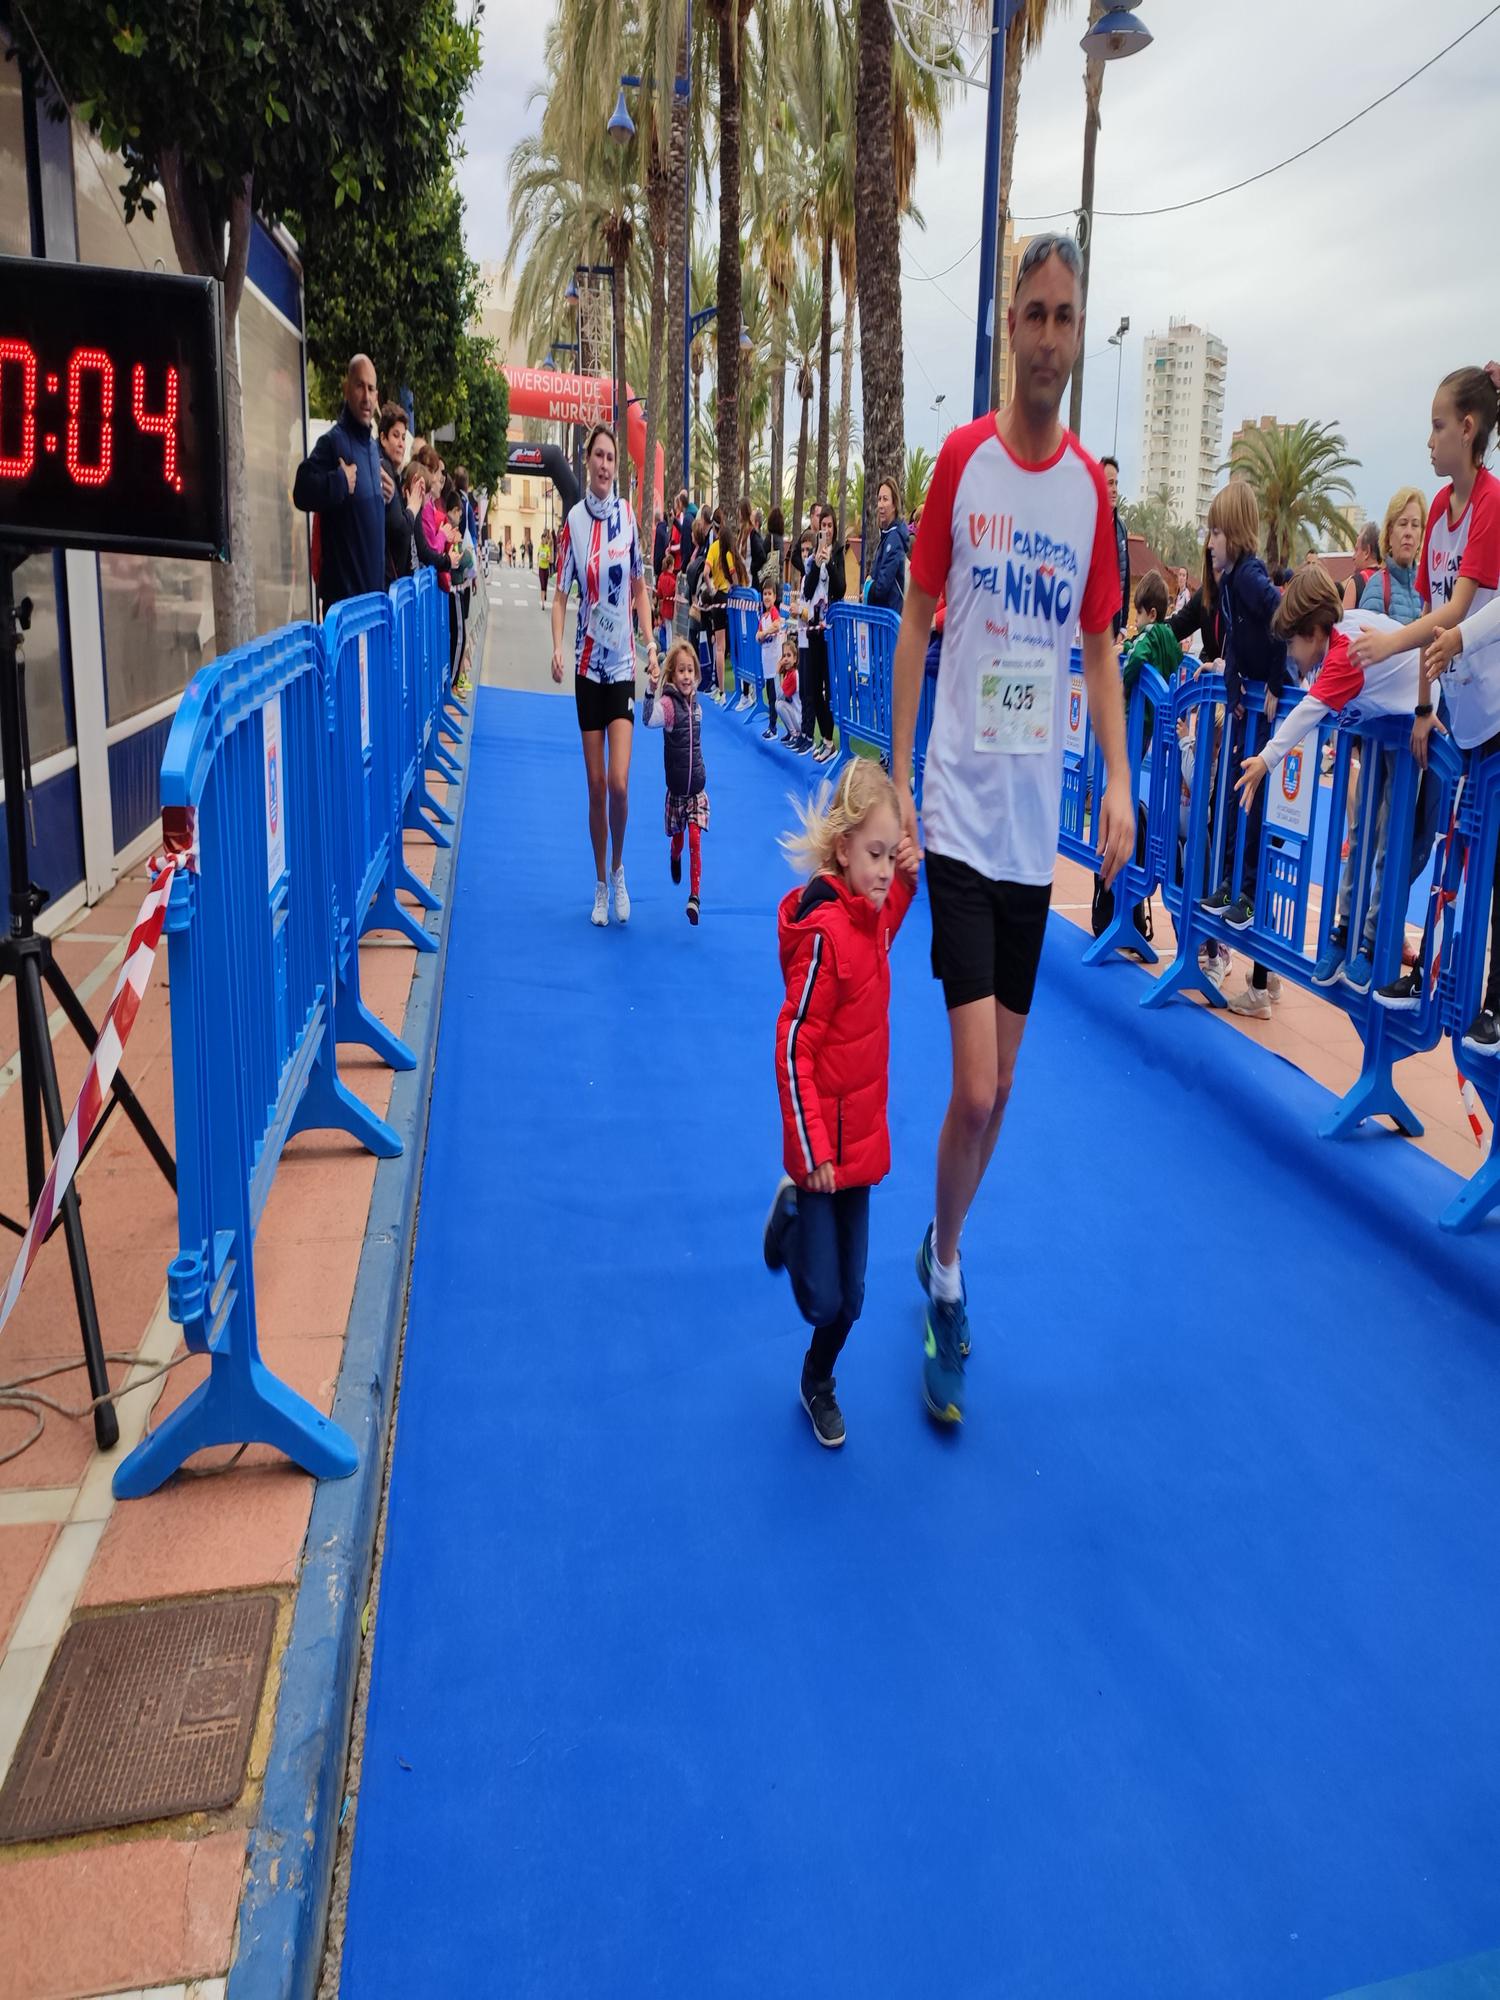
[1142,674,1462,1138]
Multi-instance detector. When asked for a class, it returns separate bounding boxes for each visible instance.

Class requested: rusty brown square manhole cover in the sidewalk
[0,1596,276,1842]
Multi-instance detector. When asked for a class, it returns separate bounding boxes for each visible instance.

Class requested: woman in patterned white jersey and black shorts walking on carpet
[552,424,656,926]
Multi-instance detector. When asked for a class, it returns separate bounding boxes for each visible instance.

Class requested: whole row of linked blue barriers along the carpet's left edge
[114,572,458,1500]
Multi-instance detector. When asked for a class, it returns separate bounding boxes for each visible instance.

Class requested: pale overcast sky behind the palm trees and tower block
[462,0,1500,516]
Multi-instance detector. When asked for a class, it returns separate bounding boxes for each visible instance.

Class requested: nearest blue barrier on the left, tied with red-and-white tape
[114,624,400,1498]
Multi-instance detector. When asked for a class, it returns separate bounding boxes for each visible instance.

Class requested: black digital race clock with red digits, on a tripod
[0,256,230,560]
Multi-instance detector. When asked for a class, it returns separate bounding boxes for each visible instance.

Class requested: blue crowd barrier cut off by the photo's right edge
[1428,734,1500,1230]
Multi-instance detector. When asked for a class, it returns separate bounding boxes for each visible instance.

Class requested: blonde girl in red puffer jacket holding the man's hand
[764,758,916,1446]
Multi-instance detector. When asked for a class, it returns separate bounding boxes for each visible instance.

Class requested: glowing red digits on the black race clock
[0,340,182,494]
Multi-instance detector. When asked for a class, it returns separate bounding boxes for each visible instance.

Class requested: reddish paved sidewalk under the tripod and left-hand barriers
[0,748,458,2000]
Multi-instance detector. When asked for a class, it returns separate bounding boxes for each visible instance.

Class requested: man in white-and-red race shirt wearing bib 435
[892,236,1136,1424]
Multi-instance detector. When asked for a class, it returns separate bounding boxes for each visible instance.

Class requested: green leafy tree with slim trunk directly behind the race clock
[12,0,480,650]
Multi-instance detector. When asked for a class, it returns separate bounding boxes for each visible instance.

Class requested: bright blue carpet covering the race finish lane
[344,690,1500,2000]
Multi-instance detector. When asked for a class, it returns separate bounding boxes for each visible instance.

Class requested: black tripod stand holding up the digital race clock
[0,548,178,1452]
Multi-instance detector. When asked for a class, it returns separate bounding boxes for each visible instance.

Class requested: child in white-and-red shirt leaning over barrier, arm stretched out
[1236,562,1438,1008]
